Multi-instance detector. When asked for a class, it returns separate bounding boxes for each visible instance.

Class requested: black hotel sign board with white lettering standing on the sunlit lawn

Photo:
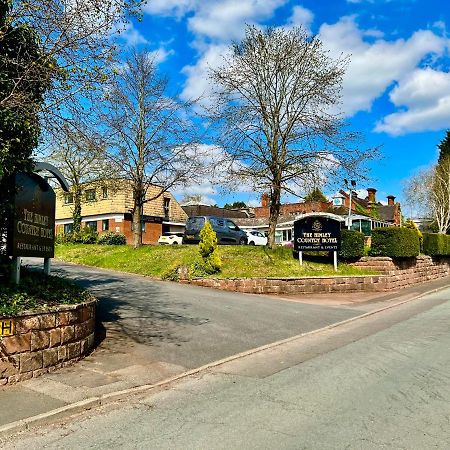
[294,216,341,252]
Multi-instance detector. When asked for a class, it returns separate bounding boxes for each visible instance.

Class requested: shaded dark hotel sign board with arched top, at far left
[7,173,55,258]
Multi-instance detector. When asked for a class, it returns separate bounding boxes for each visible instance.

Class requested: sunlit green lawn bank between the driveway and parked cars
[55,244,380,278]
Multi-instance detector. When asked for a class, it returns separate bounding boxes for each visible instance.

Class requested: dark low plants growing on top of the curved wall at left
[0,268,92,316]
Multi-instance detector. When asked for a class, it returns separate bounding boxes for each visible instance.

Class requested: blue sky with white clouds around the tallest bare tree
[118,0,450,206]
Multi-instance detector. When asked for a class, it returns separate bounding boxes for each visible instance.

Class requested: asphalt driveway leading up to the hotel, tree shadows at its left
[25,260,361,369]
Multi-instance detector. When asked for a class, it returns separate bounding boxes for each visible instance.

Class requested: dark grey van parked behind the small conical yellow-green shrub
[183,216,248,245]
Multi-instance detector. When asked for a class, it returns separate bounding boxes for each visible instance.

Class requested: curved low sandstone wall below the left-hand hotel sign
[0,300,96,385]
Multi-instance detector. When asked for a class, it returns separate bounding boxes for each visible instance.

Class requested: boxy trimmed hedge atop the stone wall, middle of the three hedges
[370,227,420,258]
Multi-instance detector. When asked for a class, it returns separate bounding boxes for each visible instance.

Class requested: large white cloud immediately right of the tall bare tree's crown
[319,16,447,116]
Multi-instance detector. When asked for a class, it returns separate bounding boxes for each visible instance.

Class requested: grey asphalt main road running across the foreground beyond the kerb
[8,289,450,450]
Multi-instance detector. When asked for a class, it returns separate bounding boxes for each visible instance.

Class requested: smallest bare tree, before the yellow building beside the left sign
[46,121,112,231]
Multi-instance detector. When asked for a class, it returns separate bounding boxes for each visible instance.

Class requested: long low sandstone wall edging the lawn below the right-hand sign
[184,256,450,294]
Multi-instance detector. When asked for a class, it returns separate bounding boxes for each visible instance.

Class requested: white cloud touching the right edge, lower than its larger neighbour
[375,68,450,135]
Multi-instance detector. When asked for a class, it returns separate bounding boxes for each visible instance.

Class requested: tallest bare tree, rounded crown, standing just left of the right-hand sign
[209,26,374,247]
